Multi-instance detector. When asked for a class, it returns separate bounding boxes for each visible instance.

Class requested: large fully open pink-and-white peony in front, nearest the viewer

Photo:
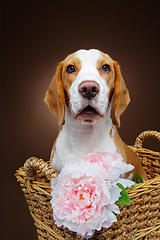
[51,163,121,237]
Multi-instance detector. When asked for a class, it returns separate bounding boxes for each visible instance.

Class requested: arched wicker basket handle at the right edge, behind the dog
[134,131,160,148]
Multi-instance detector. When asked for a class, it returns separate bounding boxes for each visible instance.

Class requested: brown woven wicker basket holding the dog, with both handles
[16,131,160,240]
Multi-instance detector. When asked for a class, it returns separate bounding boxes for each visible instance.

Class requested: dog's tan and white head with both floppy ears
[45,49,130,127]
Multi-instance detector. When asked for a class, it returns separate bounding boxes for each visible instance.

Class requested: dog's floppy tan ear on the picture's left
[44,62,65,126]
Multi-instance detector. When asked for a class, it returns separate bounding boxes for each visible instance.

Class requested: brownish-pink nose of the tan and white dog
[78,81,100,100]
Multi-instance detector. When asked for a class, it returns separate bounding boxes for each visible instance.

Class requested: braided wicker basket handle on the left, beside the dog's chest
[24,157,58,181]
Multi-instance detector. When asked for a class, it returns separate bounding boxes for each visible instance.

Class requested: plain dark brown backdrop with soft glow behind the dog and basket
[1,0,160,240]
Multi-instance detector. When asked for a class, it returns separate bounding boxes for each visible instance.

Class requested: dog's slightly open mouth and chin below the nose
[74,105,102,124]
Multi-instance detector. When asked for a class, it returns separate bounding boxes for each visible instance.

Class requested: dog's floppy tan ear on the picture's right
[111,61,130,127]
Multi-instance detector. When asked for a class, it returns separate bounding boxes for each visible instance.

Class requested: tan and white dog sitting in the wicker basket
[44,49,147,180]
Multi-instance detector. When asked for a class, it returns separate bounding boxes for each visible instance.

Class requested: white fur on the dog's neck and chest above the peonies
[51,106,117,172]
